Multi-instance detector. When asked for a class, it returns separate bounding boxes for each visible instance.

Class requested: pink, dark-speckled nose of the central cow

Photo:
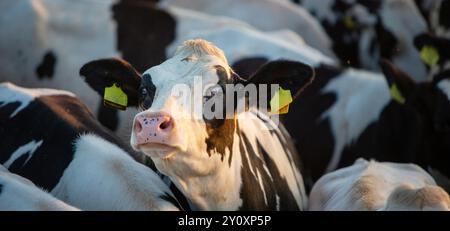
[134,115,174,144]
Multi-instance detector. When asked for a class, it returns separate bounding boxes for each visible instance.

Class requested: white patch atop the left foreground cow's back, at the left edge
[0,83,75,118]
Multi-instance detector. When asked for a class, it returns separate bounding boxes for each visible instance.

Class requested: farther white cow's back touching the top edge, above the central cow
[159,0,336,60]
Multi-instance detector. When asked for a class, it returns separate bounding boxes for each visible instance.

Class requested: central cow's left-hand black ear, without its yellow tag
[80,58,141,106]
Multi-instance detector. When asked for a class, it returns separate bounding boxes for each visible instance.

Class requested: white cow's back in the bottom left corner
[0,165,78,211]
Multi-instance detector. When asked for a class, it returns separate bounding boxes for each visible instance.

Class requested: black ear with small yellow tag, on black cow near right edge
[379,59,416,104]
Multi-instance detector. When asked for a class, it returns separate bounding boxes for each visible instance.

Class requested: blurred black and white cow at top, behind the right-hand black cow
[300,0,428,82]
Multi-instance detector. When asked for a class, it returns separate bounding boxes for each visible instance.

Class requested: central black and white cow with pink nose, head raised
[80,40,314,210]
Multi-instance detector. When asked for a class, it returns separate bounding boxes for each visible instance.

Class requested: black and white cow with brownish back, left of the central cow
[0,83,181,210]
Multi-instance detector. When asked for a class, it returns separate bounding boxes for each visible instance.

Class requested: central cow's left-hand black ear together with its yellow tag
[80,58,141,110]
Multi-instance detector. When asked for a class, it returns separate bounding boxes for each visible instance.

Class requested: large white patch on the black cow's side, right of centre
[320,69,391,171]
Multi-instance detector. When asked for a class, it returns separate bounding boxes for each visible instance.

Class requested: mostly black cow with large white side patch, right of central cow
[284,58,450,190]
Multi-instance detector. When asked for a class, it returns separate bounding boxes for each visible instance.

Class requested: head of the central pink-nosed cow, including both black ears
[80,40,314,176]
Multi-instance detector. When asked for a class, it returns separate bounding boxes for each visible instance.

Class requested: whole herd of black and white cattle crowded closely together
[0,0,450,211]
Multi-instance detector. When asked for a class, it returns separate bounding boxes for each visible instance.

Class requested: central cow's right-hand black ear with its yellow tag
[245,60,315,114]
